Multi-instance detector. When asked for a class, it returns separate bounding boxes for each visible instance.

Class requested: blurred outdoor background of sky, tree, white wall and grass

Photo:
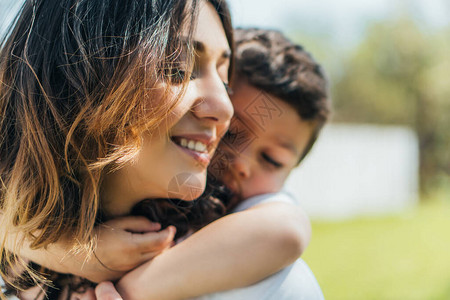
[0,0,450,300]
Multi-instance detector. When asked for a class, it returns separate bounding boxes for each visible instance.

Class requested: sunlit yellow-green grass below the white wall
[303,201,450,300]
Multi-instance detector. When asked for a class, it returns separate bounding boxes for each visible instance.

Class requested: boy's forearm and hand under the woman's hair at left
[0,214,175,282]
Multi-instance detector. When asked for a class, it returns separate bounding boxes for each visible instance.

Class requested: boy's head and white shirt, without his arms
[191,29,330,300]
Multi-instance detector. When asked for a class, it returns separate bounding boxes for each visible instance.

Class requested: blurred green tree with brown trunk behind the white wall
[333,17,450,193]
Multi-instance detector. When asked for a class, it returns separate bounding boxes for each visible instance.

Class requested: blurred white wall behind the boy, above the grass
[285,124,418,219]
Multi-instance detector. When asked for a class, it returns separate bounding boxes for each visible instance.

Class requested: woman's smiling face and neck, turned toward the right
[102,1,233,216]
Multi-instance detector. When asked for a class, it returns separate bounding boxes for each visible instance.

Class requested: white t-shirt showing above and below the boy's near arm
[195,192,324,300]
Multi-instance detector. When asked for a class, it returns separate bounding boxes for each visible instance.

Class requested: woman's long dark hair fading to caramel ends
[0,0,233,296]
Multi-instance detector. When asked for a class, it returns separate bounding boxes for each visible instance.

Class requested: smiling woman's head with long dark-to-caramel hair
[0,0,236,299]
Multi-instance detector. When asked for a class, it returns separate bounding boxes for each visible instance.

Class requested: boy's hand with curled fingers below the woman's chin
[82,217,176,282]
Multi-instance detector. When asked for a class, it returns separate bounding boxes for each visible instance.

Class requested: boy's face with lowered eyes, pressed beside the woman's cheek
[212,82,314,199]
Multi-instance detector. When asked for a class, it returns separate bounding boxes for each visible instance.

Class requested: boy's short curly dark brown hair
[234,28,331,160]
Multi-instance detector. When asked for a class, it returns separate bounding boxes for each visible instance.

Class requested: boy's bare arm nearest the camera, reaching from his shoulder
[117,202,311,300]
